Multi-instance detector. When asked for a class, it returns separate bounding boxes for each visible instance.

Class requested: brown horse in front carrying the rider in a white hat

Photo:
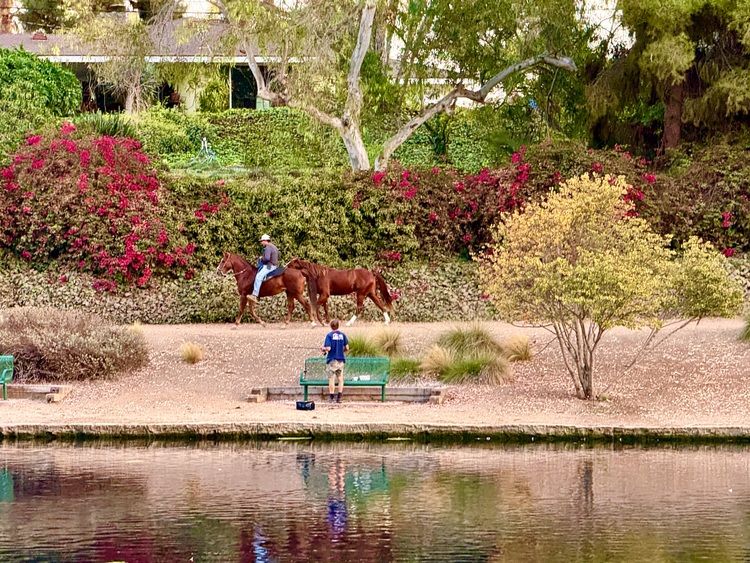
[217,252,317,326]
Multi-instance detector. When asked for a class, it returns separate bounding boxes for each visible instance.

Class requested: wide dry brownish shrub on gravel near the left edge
[0,307,148,381]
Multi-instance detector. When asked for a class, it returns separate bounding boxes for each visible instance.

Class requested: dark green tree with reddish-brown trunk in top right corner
[588,0,750,148]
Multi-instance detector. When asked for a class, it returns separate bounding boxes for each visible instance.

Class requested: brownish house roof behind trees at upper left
[0,20,268,63]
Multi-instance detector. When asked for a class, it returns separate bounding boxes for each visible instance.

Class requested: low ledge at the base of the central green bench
[247,385,446,405]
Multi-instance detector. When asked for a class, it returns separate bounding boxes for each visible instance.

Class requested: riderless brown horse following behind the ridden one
[287,258,393,326]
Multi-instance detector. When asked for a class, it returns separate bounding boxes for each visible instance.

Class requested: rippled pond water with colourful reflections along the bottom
[0,442,750,563]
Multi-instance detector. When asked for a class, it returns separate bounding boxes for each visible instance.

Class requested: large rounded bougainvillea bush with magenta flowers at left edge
[0,123,195,289]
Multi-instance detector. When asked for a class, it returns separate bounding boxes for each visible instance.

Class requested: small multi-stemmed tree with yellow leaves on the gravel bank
[479,176,742,399]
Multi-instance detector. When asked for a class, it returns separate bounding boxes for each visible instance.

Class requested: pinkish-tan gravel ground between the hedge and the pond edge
[0,319,750,427]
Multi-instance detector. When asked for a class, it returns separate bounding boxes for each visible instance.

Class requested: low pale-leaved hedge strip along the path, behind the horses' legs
[0,262,495,324]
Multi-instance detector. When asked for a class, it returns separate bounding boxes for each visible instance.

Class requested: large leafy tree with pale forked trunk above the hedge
[151,0,576,170]
